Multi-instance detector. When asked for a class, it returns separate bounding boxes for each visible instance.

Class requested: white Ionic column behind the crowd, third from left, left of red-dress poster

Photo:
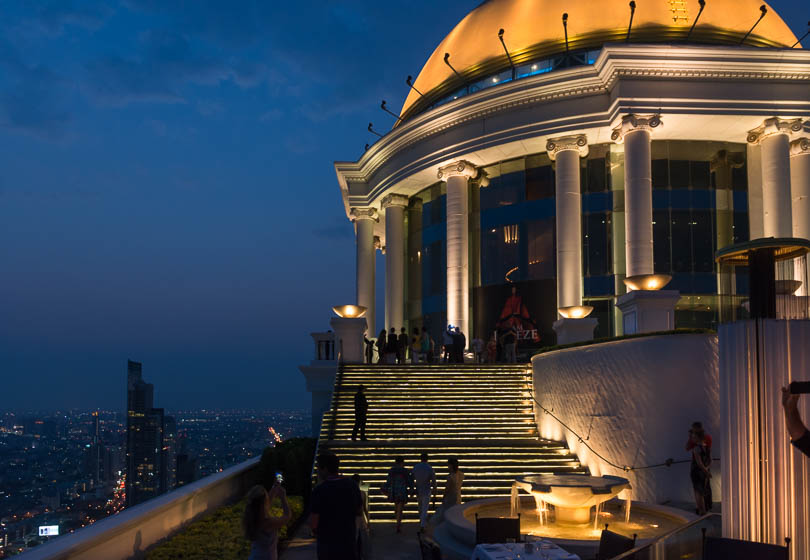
[438,161,476,342]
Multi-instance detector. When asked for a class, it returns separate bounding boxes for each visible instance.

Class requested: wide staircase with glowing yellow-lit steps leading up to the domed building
[318,364,587,521]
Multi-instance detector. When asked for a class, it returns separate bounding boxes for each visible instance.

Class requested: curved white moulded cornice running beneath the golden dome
[335,44,810,214]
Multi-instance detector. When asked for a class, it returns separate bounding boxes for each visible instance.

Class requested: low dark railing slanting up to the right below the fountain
[611,513,721,560]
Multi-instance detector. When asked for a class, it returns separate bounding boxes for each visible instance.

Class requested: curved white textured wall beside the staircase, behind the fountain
[532,334,722,503]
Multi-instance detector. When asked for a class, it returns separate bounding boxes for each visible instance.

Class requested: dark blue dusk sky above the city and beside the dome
[0,0,810,409]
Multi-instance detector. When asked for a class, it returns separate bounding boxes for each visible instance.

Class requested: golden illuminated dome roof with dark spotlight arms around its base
[400,0,796,118]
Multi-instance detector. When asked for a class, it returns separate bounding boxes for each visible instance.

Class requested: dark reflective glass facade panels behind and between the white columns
[400,141,748,346]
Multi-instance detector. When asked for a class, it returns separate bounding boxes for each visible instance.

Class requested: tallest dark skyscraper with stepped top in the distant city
[126,360,166,506]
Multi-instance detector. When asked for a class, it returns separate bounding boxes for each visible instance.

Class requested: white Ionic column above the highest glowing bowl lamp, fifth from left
[611,115,661,277]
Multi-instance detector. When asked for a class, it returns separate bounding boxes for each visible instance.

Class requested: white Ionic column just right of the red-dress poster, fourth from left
[546,135,588,309]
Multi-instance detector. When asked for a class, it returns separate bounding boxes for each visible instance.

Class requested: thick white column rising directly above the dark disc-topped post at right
[747,118,802,237]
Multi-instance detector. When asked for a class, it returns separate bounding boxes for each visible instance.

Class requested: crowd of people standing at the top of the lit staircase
[363,325,518,365]
